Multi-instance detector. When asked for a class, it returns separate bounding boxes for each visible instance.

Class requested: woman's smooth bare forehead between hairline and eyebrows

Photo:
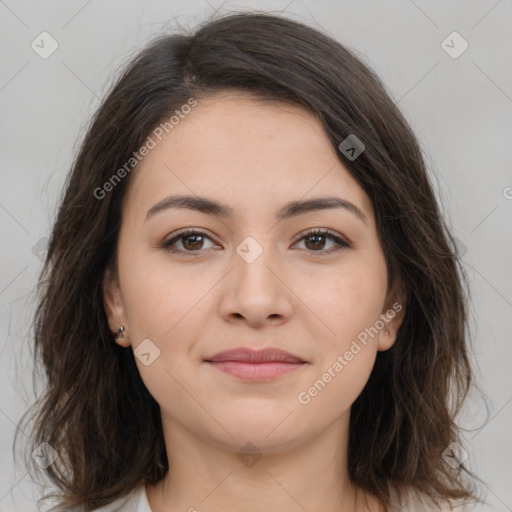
[124,93,372,224]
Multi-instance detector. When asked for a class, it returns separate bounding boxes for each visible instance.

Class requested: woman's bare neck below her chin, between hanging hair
[146,415,380,512]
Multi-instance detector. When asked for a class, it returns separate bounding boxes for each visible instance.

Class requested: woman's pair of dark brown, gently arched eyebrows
[146,195,368,224]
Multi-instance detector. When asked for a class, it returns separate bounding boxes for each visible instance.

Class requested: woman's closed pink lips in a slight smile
[205,347,307,381]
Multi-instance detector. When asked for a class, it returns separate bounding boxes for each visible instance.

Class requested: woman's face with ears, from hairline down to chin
[104,93,401,452]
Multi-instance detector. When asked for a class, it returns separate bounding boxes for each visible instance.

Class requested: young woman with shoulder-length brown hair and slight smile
[19,9,474,512]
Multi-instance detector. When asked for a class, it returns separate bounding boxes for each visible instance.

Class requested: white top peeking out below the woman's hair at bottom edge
[86,483,462,512]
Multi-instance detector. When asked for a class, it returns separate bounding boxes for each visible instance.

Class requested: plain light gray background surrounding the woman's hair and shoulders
[0,0,512,512]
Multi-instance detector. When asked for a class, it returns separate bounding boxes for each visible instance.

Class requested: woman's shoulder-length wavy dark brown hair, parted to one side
[18,9,478,510]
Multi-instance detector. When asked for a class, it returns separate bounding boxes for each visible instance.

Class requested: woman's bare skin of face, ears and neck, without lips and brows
[104,92,402,512]
